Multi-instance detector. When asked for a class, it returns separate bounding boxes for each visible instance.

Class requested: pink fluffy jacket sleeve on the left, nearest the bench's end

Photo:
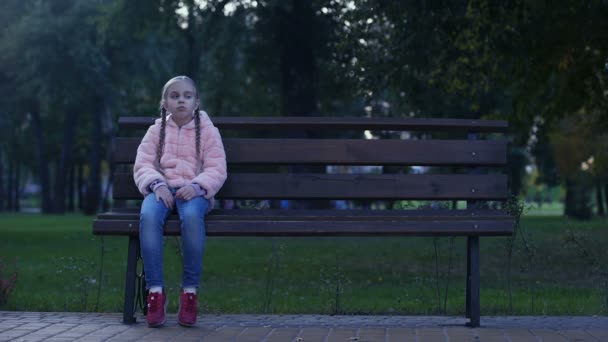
[133,125,166,196]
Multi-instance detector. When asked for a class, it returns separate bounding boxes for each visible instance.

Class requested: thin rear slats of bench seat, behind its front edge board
[97,208,513,221]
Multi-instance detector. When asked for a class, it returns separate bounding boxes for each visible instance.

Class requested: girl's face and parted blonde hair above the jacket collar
[163,80,199,124]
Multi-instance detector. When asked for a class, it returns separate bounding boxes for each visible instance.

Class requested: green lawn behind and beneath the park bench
[0,214,608,315]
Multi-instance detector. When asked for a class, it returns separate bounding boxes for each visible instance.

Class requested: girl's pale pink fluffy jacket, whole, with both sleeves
[133,111,227,209]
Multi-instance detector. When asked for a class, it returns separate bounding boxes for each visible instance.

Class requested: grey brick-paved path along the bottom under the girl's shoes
[0,311,608,342]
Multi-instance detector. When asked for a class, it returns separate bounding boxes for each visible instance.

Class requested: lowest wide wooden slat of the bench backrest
[112,173,508,200]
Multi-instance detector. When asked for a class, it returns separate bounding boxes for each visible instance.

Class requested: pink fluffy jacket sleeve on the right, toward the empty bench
[192,126,227,199]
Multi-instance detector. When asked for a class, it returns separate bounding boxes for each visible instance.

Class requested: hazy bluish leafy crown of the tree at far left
[0,0,109,110]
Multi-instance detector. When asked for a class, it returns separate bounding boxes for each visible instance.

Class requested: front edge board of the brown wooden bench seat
[93,216,513,236]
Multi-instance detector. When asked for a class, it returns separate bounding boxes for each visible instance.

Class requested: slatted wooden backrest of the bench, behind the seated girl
[112,117,508,206]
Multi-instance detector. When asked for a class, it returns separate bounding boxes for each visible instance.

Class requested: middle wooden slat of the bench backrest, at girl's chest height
[113,138,507,166]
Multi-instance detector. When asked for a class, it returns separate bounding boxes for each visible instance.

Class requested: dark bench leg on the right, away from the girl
[466,236,480,328]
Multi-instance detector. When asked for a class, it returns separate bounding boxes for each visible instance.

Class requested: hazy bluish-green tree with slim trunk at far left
[2,0,114,213]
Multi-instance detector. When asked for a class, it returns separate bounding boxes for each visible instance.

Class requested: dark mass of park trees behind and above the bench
[0,0,608,217]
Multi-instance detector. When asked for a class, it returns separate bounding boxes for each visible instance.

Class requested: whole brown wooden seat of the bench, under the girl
[93,209,514,236]
